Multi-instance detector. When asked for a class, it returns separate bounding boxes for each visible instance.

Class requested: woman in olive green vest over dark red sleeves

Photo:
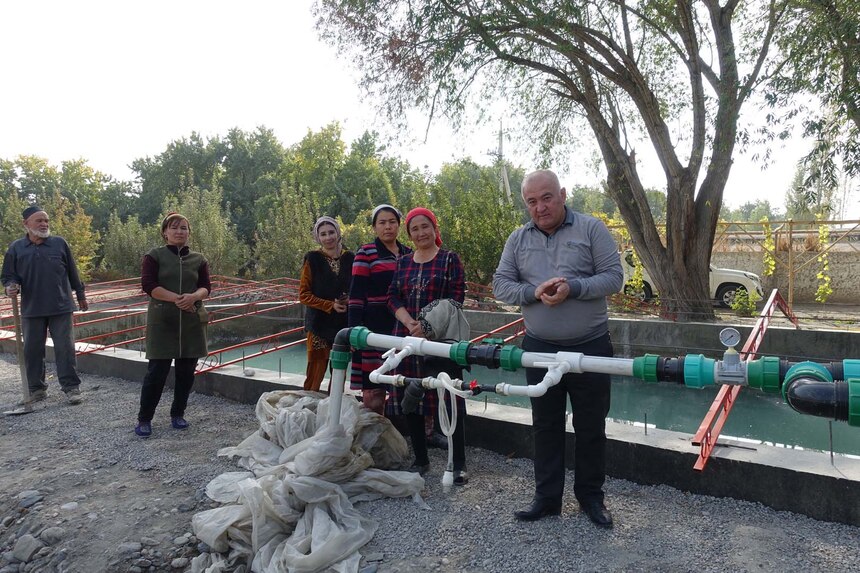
[134,213,212,438]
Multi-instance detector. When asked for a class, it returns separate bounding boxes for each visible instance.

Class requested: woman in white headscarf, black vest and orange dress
[299,216,354,392]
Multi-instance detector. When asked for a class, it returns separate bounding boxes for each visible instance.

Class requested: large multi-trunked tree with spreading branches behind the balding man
[317,0,783,317]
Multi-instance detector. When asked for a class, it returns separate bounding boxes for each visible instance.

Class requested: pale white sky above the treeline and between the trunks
[0,0,857,216]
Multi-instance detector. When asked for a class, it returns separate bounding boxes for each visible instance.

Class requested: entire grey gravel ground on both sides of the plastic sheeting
[0,355,860,573]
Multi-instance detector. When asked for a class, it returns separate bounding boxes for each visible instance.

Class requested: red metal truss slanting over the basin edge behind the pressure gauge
[693,289,800,471]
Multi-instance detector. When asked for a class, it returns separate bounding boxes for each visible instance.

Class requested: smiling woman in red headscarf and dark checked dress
[386,207,468,485]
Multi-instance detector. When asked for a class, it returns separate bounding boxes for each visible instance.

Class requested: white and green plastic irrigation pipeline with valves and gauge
[331,327,860,432]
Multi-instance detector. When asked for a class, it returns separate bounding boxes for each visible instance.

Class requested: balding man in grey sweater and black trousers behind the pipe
[493,170,623,528]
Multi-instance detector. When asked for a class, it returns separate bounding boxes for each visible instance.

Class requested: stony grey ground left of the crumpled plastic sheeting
[0,355,256,573]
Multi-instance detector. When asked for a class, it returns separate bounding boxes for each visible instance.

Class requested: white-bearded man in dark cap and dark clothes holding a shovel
[0,205,89,404]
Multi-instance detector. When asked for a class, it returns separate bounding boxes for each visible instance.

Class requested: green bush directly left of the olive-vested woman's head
[101,213,163,277]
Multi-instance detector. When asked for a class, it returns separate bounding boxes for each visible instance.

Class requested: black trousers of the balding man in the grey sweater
[523,333,613,504]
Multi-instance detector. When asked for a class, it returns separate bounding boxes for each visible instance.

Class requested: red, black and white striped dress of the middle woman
[347,239,412,390]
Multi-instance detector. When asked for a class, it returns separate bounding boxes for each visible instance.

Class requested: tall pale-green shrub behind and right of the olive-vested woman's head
[164,187,249,276]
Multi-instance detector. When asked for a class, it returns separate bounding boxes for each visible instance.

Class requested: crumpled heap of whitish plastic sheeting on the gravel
[191,391,427,573]
